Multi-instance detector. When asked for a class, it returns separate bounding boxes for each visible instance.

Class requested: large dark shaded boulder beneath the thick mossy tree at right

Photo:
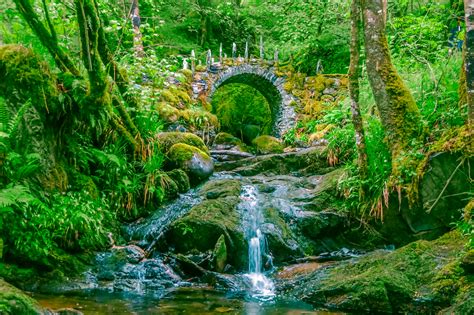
[378,152,474,245]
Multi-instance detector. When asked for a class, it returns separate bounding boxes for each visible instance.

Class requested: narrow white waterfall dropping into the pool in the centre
[239,185,275,300]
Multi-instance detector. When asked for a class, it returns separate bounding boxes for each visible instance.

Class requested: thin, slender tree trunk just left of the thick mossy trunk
[349,0,368,188]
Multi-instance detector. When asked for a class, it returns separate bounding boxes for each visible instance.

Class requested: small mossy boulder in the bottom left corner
[0,279,47,315]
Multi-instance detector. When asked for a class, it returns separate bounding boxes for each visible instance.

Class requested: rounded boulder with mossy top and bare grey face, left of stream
[167,143,214,184]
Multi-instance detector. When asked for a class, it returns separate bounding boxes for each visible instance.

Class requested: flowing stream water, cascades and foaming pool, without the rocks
[34,173,346,315]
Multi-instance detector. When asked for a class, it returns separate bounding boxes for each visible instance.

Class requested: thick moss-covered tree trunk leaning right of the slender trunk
[361,0,420,160]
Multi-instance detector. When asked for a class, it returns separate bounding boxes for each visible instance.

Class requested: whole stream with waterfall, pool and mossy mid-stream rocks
[33,149,352,315]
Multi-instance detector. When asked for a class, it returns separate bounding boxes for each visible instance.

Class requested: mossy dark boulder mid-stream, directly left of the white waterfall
[165,179,247,270]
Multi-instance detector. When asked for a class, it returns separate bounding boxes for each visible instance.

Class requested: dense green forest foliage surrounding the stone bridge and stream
[0,0,472,276]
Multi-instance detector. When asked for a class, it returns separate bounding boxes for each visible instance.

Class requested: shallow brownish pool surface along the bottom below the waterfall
[34,288,342,315]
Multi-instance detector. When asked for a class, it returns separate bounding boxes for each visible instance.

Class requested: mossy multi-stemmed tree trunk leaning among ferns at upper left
[14,0,141,151]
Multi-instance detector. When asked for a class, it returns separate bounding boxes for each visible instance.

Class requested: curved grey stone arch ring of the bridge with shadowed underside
[208,64,296,137]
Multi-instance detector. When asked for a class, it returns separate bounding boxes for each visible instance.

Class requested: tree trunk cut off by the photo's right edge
[464,0,474,125]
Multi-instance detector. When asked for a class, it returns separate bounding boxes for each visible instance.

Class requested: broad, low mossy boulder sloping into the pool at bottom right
[279,231,473,314]
